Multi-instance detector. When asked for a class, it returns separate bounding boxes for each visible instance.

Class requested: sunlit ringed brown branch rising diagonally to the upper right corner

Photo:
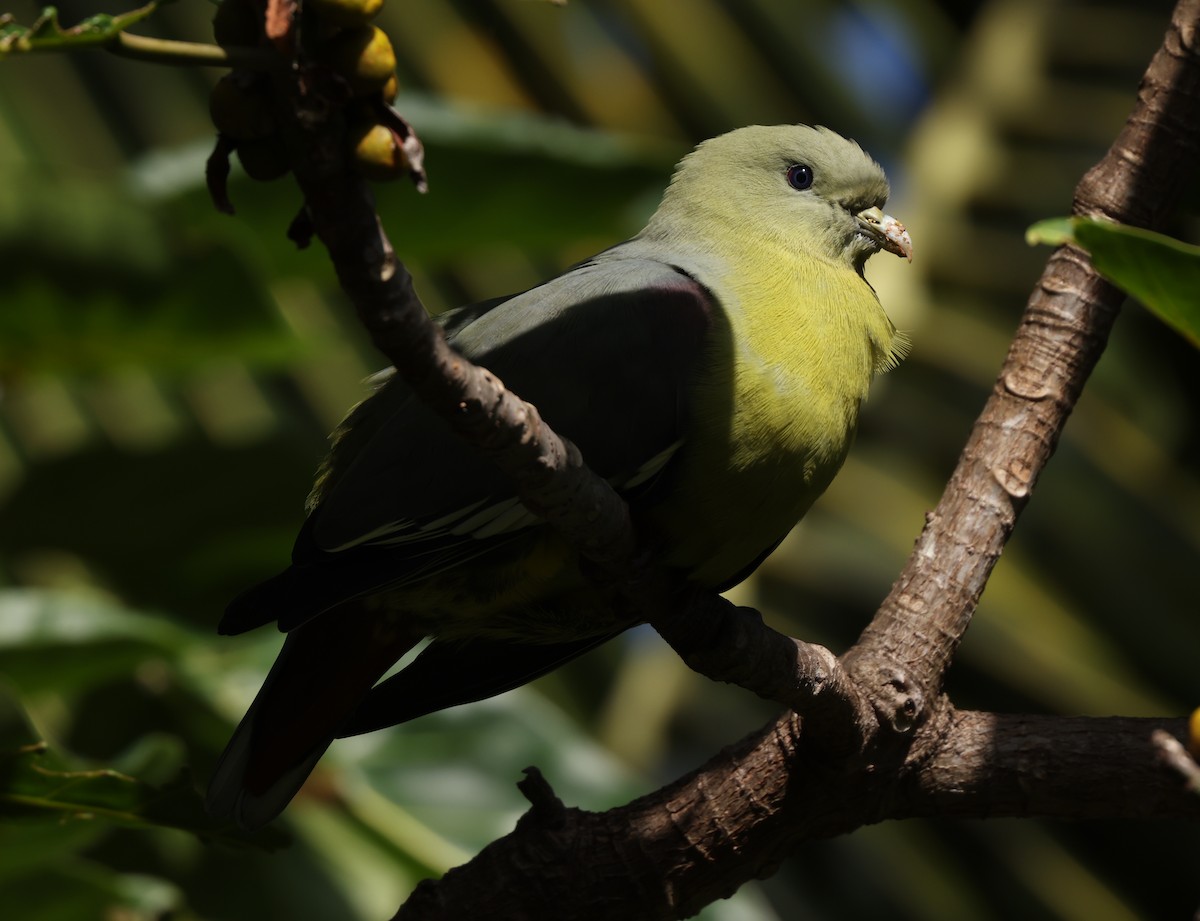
[846,0,1200,700]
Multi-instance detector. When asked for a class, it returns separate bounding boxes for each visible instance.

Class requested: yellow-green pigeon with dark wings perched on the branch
[206,125,912,829]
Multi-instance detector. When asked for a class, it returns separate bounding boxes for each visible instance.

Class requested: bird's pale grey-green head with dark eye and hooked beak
[648,125,912,272]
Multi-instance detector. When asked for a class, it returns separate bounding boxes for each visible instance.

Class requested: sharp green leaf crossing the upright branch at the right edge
[1025,217,1200,348]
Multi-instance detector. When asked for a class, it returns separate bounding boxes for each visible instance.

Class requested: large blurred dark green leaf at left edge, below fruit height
[0,167,301,380]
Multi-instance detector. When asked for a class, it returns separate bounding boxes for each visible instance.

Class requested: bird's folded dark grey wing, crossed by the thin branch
[221,251,716,632]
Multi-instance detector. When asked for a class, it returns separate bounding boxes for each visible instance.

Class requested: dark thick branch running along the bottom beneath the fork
[395,712,1200,921]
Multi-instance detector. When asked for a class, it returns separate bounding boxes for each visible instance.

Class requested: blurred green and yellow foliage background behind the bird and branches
[0,0,1200,921]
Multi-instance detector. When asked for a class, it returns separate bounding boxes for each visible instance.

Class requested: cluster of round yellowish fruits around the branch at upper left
[209,0,409,180]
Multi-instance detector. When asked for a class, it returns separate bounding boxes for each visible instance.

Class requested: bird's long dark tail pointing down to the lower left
[206,602,421,829]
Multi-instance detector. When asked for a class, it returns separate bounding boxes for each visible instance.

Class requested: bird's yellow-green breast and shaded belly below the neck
[652,255,893,585]
